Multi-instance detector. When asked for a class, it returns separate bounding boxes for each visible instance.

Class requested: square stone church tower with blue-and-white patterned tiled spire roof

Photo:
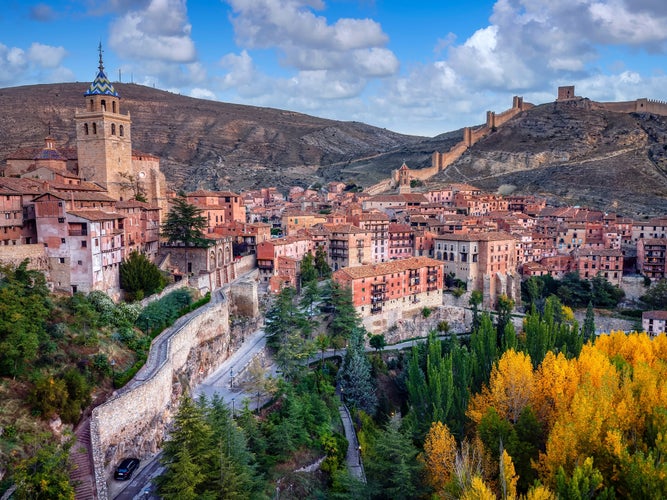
[74,43,134,200]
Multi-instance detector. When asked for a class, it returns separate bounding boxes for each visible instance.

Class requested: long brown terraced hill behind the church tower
[0,83,448,190]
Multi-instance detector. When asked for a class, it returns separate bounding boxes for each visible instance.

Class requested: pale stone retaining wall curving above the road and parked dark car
[91,291,232,499]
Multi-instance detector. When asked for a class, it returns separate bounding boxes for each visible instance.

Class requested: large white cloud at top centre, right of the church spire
[227,0,399,99]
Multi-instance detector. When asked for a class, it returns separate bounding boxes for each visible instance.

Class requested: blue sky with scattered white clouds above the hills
[0,0,667,136]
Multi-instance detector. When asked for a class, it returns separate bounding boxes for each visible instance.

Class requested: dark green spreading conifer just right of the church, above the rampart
[162,197,210,247]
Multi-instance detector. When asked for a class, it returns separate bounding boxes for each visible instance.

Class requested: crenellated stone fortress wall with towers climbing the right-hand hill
[364,85,667,195]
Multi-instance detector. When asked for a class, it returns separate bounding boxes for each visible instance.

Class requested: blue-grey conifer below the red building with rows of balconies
[338,328,377,414]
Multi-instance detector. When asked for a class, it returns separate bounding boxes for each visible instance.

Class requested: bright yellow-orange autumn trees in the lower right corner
[454,332,667,498]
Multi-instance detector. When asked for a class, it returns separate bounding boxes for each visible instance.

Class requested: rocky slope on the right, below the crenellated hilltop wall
[432,99,667,217]
